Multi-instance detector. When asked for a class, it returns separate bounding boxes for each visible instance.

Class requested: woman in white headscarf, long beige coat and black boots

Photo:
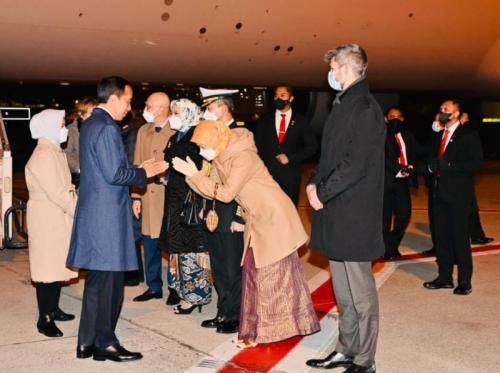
[25,109,78,337]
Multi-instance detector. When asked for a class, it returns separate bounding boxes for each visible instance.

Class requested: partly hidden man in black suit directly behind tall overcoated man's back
[383,107,420,260]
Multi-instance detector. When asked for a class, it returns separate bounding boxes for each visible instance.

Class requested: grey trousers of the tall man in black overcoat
[330,260,379,367]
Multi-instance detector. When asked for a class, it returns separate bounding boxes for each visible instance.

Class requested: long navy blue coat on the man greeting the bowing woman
[67,107,146,271]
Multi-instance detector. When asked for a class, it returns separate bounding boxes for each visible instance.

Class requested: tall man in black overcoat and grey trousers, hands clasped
[306,44,386,373]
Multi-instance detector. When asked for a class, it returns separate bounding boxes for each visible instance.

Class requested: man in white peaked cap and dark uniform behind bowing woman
[200,88,244,333]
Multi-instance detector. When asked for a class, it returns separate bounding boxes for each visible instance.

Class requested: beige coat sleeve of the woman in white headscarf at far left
[27,152,77,217]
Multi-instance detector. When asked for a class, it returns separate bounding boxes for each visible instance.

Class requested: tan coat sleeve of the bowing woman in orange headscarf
[186,152,252,203]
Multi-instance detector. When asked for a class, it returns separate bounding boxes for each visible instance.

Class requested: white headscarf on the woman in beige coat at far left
[30,109,66,146]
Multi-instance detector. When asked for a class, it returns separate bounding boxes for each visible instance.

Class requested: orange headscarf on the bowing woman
[191,120,231,156]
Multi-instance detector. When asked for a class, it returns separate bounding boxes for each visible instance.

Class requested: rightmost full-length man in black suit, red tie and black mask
[423,100,483,295]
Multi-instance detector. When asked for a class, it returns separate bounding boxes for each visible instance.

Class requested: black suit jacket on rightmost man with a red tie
[429,125,483,204]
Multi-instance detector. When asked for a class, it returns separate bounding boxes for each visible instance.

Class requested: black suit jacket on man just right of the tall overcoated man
[384,129,420,188]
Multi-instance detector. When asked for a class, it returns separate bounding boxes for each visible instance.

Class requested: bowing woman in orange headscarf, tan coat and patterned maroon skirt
[172,121,319,348]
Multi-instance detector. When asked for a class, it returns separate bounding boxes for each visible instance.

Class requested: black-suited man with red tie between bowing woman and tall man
[255,86,318,205]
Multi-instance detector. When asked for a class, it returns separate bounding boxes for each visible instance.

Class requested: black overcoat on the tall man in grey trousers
[309,79,386,262]
